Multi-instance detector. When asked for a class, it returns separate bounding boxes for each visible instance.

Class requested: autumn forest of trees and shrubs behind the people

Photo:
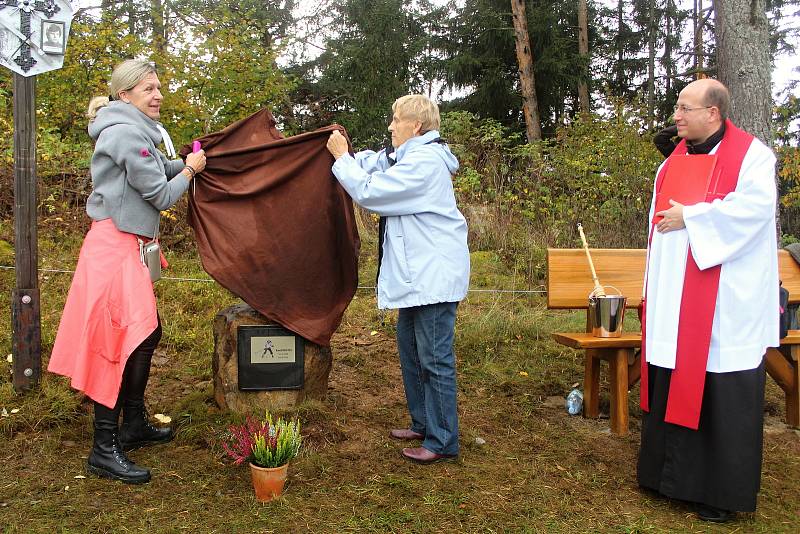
[0,0,800,266]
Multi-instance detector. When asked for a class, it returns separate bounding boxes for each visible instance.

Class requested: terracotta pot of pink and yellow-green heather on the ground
[222,411,302,502]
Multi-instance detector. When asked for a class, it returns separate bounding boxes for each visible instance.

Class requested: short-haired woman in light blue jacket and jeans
[328,95,469,463]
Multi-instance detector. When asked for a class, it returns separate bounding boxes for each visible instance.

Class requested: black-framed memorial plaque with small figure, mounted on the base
[237,325,305,391]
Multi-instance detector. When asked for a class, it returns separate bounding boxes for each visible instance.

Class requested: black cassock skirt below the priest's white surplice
[637,361,766,512]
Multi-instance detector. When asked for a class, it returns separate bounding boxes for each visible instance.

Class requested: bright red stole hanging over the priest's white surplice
[639,120,753,430]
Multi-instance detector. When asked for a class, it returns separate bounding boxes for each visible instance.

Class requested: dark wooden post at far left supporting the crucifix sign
[11,74,42,392]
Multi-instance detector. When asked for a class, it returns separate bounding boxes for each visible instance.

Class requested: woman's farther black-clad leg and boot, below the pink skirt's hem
[119,318,174,451]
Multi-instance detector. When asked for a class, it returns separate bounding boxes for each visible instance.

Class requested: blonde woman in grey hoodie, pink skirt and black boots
[48,59,206,484]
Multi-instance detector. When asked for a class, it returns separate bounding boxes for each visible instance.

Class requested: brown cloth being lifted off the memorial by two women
[180,110,360,346]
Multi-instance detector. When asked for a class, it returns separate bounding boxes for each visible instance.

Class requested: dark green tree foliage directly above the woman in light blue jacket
[294,0,443,146]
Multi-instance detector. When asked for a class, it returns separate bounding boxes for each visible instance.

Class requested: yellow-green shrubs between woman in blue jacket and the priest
[441,105,663,283]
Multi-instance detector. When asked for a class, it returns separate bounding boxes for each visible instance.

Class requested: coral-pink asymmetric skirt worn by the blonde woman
[47,219,158,408]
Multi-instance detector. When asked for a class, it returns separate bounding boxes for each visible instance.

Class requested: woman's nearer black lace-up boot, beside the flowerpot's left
[86,403,150,484]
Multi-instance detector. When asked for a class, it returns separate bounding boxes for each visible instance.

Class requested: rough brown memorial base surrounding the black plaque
[212,303,333,413]
